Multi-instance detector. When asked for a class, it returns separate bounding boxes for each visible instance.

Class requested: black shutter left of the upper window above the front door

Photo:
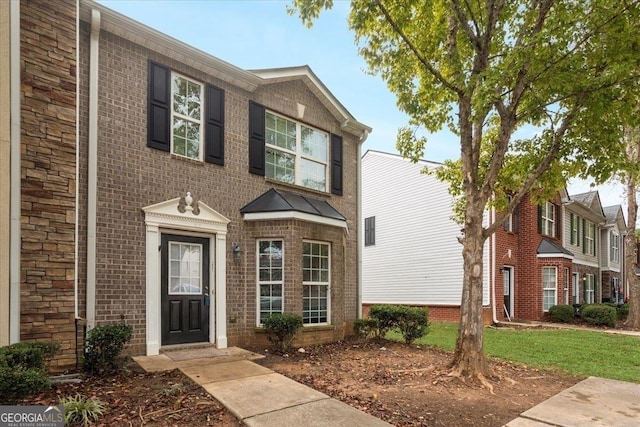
[147,61,171,151]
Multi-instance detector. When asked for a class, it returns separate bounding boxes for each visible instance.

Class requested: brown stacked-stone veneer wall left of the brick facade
[20,0,77,368]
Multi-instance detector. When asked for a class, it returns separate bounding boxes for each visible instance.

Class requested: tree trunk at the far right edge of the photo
[624,172,640,328]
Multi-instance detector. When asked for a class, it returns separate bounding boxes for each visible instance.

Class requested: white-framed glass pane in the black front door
[169,242,202,295]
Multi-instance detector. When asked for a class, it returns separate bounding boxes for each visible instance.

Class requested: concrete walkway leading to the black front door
[134,347,391,427]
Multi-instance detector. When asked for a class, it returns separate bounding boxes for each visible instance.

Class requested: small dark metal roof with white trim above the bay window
[240,188,347,228]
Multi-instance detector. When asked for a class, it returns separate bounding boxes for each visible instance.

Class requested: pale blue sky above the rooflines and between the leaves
[99,0,623,210]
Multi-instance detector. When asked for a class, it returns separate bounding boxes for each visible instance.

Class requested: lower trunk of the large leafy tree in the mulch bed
[450,201,491,382]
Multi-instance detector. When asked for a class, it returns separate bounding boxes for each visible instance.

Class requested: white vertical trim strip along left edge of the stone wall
[9,1,22,344]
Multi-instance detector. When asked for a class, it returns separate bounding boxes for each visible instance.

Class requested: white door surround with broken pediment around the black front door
[142,197,230,356]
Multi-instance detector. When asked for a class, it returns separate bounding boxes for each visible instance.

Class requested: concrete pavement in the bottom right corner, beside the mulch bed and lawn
[506,377,640,427]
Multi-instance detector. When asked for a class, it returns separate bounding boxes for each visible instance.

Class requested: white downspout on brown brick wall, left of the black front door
[87,9,100,329]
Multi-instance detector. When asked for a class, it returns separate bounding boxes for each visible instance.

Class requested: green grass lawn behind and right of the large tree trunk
[389,322,640,383]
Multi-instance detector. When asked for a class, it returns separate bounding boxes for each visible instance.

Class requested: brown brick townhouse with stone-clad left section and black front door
[0,0,371,365]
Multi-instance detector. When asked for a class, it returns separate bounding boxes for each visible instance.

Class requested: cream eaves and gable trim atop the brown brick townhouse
[80,0,371,137]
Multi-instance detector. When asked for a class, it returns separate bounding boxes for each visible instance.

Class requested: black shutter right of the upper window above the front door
[204,84,224,166]
